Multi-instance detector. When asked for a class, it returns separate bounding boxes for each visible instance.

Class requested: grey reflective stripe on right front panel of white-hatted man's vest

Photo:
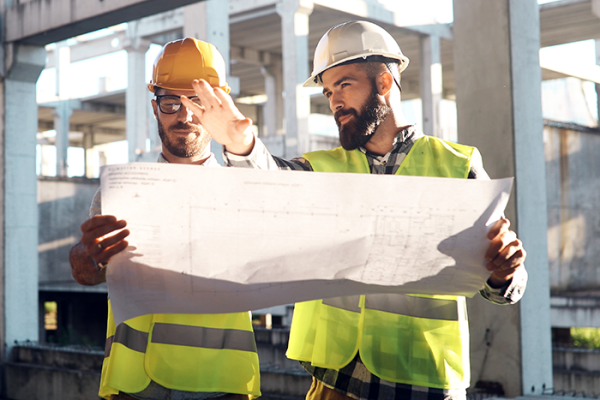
[365,294,467,321]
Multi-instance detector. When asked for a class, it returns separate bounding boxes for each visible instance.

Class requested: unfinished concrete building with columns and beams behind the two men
[0,0,600,399]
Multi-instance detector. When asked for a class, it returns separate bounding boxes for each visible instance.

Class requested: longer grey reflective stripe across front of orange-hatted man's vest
[152,323,256,352]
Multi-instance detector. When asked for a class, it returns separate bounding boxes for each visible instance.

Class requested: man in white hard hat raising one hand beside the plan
[183,21,527,399]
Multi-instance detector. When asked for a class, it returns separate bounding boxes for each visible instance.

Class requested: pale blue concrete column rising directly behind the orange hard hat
[183,0,240,164]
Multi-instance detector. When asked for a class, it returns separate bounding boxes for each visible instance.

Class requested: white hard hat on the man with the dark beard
[304,21,409,86]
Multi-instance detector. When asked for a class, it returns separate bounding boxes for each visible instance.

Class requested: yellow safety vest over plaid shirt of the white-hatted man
[287,136,474,389]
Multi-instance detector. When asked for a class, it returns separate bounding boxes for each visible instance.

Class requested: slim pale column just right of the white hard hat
[420,36,445,139]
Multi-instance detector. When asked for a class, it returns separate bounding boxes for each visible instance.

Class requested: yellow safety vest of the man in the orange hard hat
[99,300,260,398]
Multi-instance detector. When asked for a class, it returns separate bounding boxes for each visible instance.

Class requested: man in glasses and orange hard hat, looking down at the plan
[70,38,260,400]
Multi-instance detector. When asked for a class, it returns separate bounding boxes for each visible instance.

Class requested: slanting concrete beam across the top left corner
[4,0,202,45]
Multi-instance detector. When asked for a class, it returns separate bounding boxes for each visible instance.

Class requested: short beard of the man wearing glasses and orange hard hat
[158,120,211,158]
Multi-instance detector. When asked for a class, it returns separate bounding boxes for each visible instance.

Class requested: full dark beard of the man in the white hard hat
[334,88,391,150]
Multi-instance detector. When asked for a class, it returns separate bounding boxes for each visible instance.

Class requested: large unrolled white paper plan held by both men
[101,163,512,323]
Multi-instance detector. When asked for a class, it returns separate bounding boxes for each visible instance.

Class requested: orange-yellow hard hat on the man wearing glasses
[148,38,231,93]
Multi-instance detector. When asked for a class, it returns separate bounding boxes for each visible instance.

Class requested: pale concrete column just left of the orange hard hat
[123,21,150,162]
